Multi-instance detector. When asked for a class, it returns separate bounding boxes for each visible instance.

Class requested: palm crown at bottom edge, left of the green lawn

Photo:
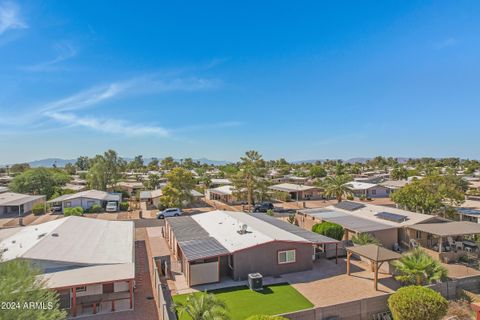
[173,292,230,320]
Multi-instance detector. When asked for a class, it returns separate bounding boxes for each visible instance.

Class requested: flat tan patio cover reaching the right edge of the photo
[409,221,480,237]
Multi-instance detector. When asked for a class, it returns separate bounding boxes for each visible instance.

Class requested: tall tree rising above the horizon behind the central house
[232,150,266,210]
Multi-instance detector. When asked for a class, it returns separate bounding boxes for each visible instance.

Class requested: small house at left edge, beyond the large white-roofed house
[0,192,45,216]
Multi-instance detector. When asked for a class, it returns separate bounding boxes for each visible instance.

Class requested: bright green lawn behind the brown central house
[173,284,313,320]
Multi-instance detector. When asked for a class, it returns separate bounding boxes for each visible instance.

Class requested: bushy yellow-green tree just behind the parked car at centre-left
[160,167,196,207]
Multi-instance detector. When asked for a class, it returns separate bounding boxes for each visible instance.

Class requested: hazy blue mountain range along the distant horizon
[0,157,409,168]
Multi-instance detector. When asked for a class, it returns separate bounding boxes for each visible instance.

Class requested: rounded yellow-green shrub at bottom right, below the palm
[388,286,448,320]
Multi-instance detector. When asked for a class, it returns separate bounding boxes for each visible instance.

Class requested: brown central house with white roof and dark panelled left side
[165,210,339,286]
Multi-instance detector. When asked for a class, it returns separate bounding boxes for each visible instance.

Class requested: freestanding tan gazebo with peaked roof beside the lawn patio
[346,244,402,290]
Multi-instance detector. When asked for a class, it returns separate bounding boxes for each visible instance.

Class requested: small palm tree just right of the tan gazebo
[393,248,448,285]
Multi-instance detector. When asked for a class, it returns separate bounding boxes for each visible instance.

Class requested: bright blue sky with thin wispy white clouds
[0,0,480,163]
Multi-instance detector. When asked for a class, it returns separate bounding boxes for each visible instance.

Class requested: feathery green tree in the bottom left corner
[0,257,67,320]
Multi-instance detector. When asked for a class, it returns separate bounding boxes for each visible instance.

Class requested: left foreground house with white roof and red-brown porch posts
[0,216,135,317]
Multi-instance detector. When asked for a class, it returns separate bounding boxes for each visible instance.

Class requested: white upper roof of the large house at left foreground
[0,216,134,264]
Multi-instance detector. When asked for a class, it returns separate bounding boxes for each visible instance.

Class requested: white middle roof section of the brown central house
[192,210,308,252]
